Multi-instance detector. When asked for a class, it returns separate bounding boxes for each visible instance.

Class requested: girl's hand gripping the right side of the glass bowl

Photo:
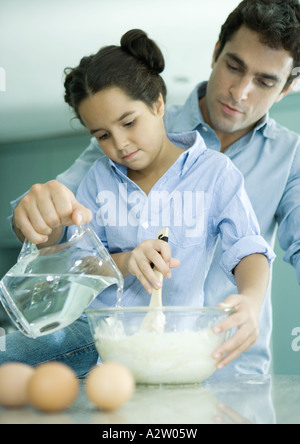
[213,294,260,370]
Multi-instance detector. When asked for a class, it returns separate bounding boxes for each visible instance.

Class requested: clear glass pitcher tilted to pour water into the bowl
[0,227,124,338]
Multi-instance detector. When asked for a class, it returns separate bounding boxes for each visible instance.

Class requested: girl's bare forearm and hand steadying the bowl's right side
[213,254,270,370]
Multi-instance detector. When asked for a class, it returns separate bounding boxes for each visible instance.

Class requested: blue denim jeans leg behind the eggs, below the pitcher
[0,318,99,377]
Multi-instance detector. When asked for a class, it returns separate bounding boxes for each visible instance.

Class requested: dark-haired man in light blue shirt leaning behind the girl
[8,0,300,373]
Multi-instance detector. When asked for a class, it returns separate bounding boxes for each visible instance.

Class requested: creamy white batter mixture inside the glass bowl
[94,320,223,384]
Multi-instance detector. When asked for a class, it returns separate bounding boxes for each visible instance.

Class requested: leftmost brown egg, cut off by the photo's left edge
[0,362,34,408]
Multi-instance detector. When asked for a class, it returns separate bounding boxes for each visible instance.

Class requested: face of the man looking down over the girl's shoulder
[205,26,293,134]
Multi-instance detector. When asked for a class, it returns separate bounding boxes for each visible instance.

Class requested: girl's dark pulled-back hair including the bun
[65,29,167,122]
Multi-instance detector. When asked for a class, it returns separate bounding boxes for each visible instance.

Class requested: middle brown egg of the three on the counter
[28,362,79,412]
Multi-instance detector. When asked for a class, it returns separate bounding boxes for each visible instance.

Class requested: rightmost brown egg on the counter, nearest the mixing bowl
[86,362,135,411]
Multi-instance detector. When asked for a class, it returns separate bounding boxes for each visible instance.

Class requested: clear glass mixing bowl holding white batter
[86,307,234,384]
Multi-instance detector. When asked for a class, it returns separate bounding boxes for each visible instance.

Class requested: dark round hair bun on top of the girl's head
[121,29,165,74]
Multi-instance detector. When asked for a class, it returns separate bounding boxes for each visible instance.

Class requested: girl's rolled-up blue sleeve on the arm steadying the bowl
[214,160,276,284]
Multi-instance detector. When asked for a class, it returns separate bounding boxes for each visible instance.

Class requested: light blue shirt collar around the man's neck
[176,82,275,139]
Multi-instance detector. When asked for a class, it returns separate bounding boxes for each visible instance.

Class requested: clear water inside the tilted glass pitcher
[2,273,122,337]
